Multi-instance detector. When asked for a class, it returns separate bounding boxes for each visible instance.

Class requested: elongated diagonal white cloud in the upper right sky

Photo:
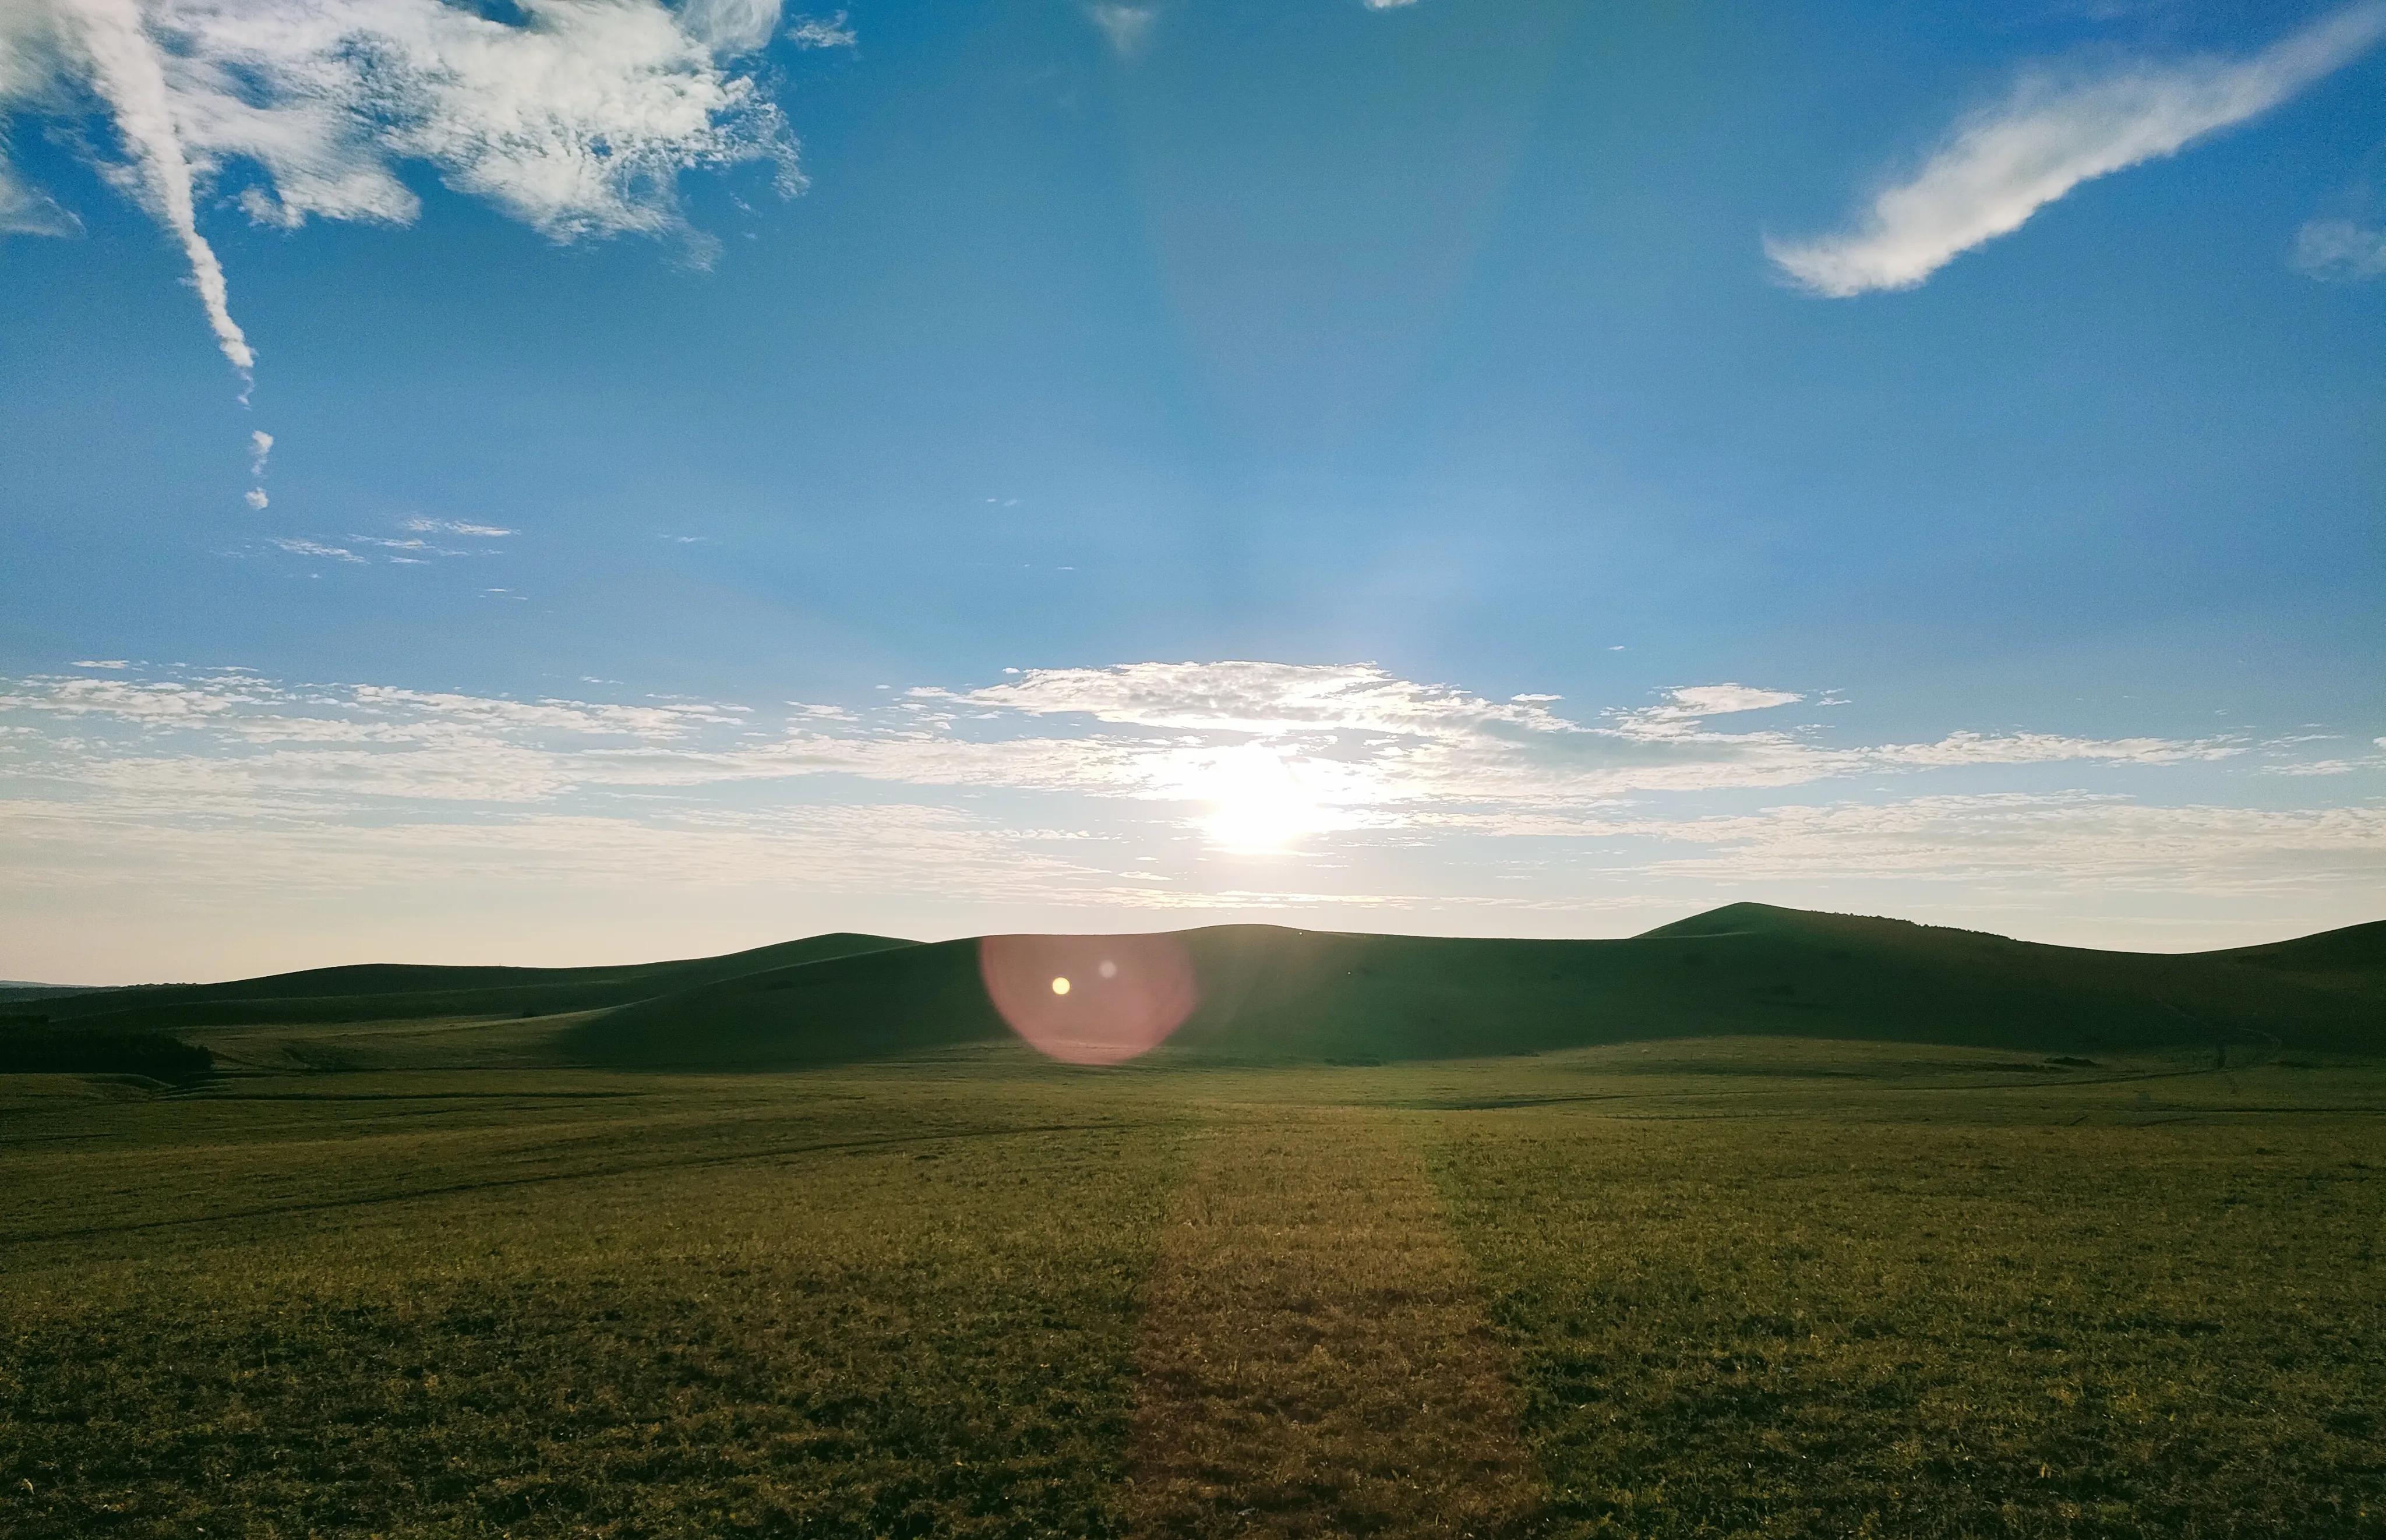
[1766,0,2386,298]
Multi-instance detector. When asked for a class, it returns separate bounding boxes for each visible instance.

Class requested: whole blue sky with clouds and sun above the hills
[0,0,2386,982]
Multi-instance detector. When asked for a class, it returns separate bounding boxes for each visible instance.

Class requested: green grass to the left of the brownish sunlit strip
[0,1078,1176,1538]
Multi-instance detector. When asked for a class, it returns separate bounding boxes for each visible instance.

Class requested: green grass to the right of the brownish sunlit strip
[1439,1078,2386,1538]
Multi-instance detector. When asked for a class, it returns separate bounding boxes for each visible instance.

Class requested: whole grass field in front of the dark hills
[0,1044,2386,1540]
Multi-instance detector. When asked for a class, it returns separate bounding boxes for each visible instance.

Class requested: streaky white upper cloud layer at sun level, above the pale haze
[0,658,2245,832]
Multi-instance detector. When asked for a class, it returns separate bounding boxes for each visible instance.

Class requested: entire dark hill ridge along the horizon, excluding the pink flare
[0,903,2386,1071]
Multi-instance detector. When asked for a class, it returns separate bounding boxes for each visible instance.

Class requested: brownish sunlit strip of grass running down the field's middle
[1131,1108,1537,1535]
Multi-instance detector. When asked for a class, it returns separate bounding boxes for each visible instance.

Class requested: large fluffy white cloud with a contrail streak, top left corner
[0,0,799,375]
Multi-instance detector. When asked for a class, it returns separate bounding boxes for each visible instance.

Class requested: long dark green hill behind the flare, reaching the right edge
[561,903,2386,1068]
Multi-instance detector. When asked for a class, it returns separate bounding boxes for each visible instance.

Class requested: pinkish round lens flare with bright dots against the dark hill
[978,937,1200,1063]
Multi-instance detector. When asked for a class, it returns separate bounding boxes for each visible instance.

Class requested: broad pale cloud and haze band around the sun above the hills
[0,662,2386,925]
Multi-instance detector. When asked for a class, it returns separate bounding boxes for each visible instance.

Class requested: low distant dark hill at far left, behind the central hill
[0,932,912,1030]
